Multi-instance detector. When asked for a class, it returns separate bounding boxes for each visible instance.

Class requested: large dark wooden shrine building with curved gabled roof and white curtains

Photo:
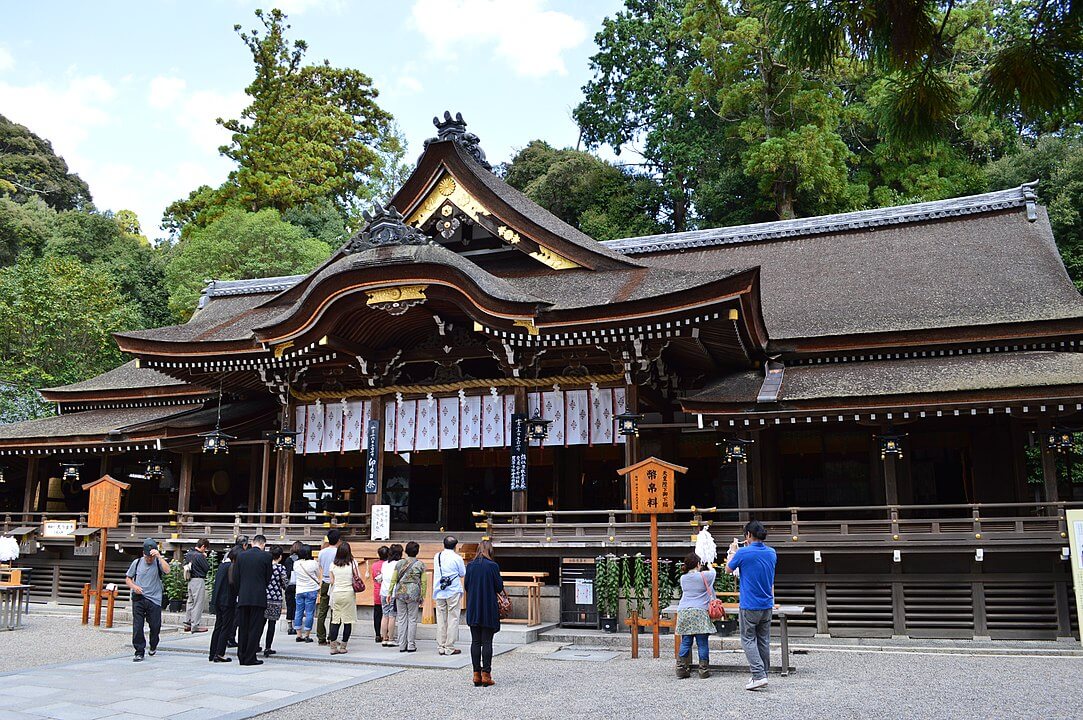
[0,114,1083,638]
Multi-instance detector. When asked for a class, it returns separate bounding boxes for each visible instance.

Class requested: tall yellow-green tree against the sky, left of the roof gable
[218,10,397,214]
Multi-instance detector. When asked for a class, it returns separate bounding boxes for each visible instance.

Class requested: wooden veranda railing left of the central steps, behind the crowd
[0,510,368,544]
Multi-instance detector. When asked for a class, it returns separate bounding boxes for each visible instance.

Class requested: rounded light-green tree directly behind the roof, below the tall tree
[166,208,331,318]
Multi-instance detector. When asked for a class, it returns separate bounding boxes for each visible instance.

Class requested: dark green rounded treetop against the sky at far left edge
[0,115,91,210]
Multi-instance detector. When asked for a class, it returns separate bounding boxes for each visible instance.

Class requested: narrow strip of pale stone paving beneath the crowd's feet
[159,630,514,666]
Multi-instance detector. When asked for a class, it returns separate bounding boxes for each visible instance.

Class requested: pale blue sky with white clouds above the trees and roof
[0,0,622,238]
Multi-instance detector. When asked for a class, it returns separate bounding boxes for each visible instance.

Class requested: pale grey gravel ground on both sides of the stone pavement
[0,615,1083,720]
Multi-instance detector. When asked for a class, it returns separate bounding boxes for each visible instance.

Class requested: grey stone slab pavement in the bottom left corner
[0,647,401,720]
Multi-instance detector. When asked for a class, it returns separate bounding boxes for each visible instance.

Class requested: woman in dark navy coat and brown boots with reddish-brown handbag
[464,540,502,688]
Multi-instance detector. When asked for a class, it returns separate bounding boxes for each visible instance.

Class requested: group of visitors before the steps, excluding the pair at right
[127,528,506,686]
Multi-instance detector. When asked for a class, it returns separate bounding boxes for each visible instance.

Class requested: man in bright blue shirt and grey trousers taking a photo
[726,520,778,690]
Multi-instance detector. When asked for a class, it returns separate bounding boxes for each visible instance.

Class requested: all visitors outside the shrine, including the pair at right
[125,520,777,690]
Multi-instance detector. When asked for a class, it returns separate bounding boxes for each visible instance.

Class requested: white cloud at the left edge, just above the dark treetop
[0,75,116,156]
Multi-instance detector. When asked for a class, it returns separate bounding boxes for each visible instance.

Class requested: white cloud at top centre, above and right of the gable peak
[410,0,587,78]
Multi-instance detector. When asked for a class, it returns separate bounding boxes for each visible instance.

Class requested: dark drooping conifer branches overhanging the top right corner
[765,0,1083,140]
